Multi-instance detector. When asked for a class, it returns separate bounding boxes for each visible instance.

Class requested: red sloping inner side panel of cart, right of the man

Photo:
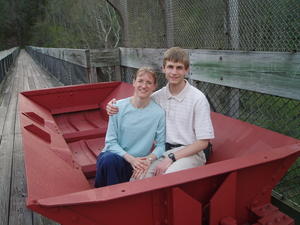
[210,113,300,162]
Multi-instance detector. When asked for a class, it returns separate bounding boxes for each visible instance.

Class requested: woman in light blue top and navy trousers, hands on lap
[95,67,165,187]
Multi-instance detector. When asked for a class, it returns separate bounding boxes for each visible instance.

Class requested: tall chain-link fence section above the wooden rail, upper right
[109,0,300,51]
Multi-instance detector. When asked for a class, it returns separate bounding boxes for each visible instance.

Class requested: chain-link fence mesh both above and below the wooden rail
[109,0,300,210]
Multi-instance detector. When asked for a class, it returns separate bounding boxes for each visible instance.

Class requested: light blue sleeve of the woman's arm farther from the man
[105,115,126,157]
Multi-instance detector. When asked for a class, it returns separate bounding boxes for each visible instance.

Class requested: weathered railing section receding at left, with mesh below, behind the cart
[26,46,120,85]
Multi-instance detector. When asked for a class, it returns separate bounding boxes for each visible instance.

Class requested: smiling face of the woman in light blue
[133,72,156,98]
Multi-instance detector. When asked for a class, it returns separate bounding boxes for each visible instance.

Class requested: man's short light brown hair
[163,47,190,69]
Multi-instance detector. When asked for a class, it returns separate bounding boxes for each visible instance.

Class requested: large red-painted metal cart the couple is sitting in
[20,82,300,225]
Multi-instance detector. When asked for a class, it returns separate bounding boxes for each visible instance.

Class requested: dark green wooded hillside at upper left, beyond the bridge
[0,0,121,50]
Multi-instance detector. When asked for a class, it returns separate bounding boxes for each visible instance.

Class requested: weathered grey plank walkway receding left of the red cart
[0,50,61,225]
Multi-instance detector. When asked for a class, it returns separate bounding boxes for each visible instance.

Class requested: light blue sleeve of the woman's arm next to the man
[152,113,166,158]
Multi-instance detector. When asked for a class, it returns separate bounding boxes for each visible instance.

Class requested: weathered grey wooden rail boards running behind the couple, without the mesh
[28,46,300,100]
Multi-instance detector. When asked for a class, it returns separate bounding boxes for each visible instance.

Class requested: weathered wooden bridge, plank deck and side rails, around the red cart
[0,47,300,225]
